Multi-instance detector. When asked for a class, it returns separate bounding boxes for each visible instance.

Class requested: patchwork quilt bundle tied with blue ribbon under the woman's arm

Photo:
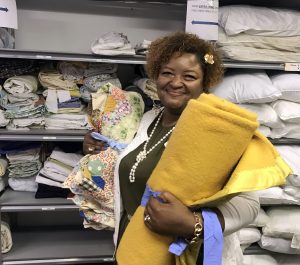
[64,83,144,229]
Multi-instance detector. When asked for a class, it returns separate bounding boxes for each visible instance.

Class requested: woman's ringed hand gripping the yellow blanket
[144,192,195,238]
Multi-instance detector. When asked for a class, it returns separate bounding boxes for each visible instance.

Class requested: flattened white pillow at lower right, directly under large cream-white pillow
[258,235,300,254]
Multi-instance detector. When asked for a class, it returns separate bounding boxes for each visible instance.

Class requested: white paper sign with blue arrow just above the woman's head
[185,0,219,40]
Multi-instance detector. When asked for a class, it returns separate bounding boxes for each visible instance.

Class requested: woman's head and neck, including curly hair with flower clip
[147,32,223,119]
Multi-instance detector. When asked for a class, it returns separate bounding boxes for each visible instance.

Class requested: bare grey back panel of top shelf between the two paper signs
[15,0,186,53]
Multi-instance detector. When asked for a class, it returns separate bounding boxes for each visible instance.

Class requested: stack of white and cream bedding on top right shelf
[218,5,300,62]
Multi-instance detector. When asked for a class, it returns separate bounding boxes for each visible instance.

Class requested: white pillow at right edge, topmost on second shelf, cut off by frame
[270,74,300,103]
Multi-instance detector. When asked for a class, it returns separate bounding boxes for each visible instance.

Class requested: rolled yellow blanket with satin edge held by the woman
[117,94,290,265]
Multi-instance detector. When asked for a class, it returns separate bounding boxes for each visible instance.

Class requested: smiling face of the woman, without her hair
[156,53,203,114]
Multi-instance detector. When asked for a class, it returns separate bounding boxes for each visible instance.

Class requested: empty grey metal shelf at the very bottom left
[2,227,114,265]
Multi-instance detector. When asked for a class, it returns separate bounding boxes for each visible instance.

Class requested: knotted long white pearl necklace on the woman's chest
[129,111,175,183]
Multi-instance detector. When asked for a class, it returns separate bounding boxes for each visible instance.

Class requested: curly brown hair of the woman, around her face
[146,32,224,93]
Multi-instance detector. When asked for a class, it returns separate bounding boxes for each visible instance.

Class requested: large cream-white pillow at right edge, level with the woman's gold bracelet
[262,206,300,239]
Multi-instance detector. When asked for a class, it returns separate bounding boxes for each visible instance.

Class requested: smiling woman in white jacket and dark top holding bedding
[83,32,259,264]
